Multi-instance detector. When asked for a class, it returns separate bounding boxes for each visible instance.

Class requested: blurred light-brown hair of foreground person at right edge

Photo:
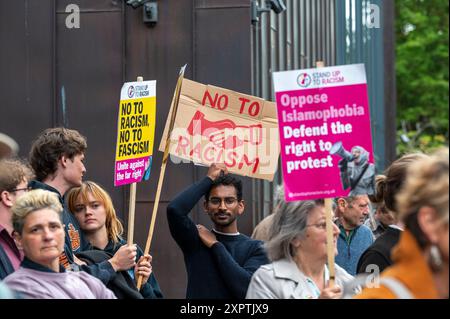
[397,148,449,223]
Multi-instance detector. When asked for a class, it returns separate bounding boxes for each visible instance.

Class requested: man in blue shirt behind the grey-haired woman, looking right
[335,195,373,276]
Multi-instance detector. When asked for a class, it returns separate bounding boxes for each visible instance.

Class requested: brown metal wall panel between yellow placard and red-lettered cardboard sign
[124,0,194,298]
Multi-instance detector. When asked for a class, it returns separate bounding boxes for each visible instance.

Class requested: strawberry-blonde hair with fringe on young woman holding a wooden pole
[67,181,123,243]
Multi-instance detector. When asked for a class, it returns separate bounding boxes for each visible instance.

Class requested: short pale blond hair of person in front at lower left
[12,189,63,234]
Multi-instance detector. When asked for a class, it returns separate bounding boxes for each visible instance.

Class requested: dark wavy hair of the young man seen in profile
[29,127,87,181]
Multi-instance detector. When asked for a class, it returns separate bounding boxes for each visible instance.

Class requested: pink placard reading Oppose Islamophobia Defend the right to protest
[273,64,375,201]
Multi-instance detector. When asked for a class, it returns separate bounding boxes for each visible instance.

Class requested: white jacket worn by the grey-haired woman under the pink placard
[246,259,353,299]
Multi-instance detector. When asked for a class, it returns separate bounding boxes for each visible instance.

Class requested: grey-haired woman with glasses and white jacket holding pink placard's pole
[246,189,353,299]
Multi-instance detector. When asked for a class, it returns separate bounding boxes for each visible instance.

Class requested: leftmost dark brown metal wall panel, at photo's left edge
[0,0,54,157]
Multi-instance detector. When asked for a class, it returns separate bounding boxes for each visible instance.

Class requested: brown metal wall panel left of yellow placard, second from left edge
[56,8,124,222]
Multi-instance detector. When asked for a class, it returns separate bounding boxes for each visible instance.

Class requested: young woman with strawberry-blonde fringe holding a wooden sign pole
[67,181,163,299]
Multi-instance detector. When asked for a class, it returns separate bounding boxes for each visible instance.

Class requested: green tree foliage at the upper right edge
[395,0,449,154]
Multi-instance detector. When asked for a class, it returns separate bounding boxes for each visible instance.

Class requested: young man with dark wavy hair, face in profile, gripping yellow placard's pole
[29,127,136,285]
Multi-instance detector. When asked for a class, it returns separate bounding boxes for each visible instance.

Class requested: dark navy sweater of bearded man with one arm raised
[167,177,269,299]
